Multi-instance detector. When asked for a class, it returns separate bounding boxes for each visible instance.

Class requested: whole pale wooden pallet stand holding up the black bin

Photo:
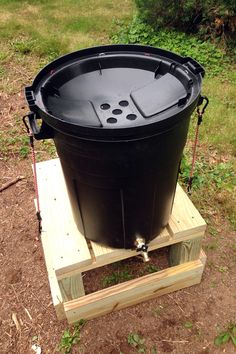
[37,159,206,323]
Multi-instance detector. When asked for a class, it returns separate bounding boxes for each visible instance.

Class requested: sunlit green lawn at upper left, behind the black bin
[0,0,132,59]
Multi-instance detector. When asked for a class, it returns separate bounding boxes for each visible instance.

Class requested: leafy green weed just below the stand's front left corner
[58,320,85,354]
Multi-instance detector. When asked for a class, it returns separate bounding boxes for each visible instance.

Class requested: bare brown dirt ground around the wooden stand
[0,95,236,354]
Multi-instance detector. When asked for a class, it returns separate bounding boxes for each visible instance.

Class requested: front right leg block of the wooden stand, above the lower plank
[169,236,202,267]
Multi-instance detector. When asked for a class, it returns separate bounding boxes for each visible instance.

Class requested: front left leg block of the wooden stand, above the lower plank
[58,273,85,301]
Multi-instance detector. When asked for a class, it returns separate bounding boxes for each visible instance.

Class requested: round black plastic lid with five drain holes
[26,45,204,136]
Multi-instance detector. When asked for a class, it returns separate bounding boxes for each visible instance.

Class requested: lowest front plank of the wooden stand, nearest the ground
[64,260,204,323]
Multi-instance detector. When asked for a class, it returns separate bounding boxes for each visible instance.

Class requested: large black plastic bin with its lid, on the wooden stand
[25,45,204,248]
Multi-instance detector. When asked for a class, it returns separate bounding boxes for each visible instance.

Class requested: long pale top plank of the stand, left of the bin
[37,159,92,273]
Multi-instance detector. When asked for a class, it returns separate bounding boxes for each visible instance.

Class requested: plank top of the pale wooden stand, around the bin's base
[37,159,206,279]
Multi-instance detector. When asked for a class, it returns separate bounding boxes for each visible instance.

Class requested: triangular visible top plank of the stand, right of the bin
[167,184,206,238]
